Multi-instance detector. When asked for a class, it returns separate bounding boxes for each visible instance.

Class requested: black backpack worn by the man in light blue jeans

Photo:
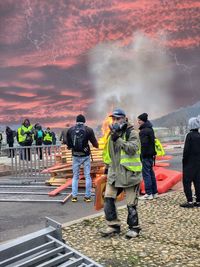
[71,124,87,152]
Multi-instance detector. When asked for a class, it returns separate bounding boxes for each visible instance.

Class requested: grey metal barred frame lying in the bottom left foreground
[0,218,102,267]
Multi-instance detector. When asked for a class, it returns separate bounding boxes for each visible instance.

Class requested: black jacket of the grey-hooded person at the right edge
[183,129,200,179]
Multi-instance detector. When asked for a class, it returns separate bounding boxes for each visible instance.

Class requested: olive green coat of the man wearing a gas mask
[107,130,142,188]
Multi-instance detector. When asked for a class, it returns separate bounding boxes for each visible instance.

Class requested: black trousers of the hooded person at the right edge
[183,171,200,202]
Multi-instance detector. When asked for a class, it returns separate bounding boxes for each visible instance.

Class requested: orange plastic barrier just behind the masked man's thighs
[94,175,124,210]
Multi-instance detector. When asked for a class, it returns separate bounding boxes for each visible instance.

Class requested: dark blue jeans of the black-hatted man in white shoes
[142,158,158,195]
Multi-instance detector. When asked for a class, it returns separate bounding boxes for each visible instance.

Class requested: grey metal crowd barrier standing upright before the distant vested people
[3,145,61,177]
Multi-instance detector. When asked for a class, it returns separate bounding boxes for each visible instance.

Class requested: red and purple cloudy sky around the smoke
[0,0,200,130]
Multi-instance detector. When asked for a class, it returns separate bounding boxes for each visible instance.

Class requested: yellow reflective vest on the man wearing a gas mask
[103,136,142,172]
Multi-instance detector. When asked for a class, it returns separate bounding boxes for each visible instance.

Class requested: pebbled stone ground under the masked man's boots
[63,191,200,267]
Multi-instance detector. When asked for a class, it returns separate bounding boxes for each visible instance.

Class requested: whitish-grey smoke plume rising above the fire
[90,33,173,120]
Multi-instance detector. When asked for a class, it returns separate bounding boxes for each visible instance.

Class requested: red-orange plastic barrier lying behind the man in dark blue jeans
[140,167,182,194]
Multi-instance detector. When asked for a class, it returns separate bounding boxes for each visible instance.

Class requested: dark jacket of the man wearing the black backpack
[67,126,99,157]
